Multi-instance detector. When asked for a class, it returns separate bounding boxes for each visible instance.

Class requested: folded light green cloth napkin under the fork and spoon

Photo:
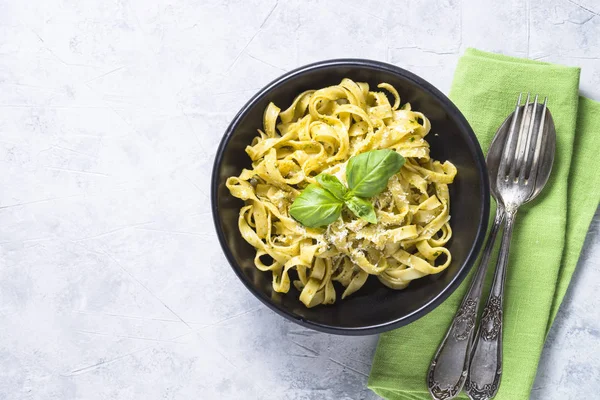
[368,49,600,400]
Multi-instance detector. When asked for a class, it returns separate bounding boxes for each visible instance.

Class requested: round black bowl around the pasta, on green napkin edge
[211,59,490,335]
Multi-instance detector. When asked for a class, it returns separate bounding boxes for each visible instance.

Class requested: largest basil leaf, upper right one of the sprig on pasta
[346,149,404,197]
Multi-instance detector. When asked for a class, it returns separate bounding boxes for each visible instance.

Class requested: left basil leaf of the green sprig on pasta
[290,183,344,228]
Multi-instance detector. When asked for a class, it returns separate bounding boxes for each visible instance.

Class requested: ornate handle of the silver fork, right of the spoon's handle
[465,209,517,400]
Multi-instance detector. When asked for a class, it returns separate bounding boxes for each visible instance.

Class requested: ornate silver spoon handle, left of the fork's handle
[427,204,504,400]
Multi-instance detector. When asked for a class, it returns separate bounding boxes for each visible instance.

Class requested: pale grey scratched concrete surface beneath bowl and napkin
[0,0,600,400]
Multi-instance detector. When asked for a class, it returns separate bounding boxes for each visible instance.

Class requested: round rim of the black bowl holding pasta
[210,58,490,336]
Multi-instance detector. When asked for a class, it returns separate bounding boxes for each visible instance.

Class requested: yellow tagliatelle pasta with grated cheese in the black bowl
[226,79,457,307]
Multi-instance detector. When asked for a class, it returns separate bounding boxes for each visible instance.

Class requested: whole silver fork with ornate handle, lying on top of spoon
[465,93,554,400]
